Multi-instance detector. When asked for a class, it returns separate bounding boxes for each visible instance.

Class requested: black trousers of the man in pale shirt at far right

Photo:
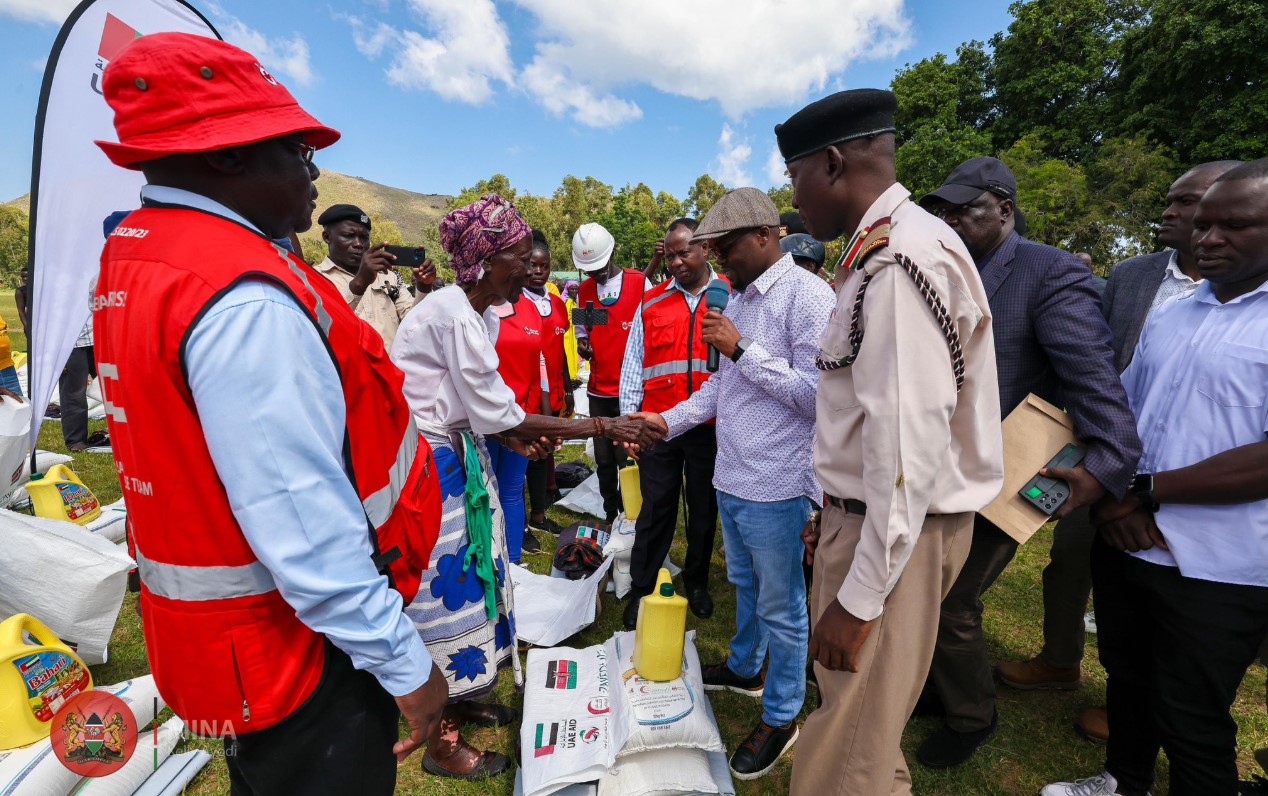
[1092,535,1268,796]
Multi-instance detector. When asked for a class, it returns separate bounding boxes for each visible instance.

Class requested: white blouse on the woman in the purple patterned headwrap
[392,285,525,446]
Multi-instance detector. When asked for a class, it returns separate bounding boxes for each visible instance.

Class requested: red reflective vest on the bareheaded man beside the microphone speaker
[643,280,729,412]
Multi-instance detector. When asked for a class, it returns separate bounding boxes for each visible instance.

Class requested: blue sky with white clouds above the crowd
[0,0,1011,200]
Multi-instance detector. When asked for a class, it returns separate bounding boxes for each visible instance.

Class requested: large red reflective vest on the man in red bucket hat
[94,208,440,735]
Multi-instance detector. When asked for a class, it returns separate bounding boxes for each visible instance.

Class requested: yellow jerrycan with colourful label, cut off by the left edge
[0,613,93,750]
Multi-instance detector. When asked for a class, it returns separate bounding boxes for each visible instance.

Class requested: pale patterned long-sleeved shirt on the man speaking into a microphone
[663,255,837,503]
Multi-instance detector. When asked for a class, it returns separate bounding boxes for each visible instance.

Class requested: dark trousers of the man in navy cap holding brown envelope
[926,515,1017,733]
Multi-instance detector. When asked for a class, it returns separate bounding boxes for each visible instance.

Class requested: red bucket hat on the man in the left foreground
[96,33,339,169]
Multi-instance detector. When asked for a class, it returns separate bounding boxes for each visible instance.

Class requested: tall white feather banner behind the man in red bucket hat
[27,0,219,449]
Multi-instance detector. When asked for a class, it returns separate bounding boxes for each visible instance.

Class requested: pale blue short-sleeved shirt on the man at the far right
[1122,281,1268,586]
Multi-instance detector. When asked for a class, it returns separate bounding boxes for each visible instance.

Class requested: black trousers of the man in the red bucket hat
[224,641,401,796]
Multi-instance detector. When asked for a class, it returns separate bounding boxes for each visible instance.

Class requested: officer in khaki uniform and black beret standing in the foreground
[775,89,1003,796]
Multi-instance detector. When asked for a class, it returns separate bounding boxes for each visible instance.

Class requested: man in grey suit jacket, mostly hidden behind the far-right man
[997,161,1240,743]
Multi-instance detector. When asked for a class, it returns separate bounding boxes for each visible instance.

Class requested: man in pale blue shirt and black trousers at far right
[1042,158,1268,796]
